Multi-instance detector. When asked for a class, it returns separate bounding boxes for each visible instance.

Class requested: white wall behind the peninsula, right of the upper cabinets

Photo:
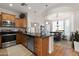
[27,13,44,33]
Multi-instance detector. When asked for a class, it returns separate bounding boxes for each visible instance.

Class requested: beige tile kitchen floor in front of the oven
[0,44,34,56]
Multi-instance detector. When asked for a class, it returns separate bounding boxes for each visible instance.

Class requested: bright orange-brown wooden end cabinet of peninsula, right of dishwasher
[35,37,49,56]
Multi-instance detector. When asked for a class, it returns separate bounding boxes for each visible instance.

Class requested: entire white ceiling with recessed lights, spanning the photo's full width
[0,3,79,13]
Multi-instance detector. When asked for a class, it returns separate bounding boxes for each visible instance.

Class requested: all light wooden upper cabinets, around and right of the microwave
[0,12,27,28]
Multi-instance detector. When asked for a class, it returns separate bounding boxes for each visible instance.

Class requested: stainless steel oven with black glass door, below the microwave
[2,32,16,48]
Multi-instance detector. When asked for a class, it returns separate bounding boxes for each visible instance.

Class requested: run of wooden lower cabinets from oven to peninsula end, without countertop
[16,33,49,56]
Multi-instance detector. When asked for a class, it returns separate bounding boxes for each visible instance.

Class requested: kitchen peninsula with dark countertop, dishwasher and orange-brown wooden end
[24,33,52,56]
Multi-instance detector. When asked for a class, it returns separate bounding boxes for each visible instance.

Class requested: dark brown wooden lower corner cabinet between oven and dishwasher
[16,32,27,47]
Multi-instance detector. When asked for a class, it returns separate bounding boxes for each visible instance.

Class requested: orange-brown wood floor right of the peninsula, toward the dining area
[49,40,79,56]
